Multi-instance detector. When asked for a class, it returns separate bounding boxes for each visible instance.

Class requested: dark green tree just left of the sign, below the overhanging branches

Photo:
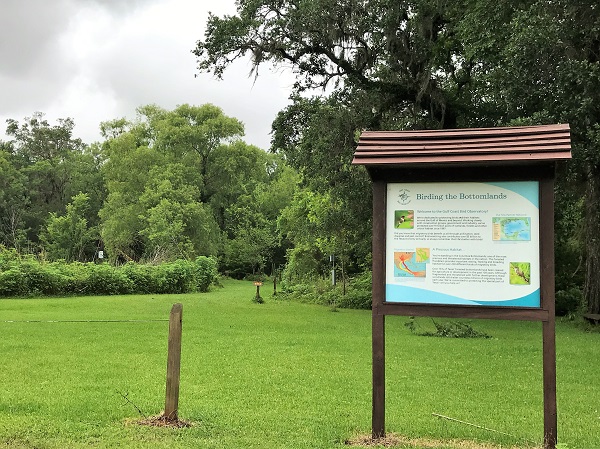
[273,95,372,279]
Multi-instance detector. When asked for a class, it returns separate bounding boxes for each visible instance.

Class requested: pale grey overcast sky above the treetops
[0,0,293,149]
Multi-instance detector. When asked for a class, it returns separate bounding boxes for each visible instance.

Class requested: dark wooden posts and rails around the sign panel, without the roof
[370,164,557,449]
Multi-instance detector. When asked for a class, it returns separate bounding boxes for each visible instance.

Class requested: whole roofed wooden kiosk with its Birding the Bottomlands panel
[352,125,571,449]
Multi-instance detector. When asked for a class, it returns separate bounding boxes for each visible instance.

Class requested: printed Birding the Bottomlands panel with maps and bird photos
[385,181,540,308]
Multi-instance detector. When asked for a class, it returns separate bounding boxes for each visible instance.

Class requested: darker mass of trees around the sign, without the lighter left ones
[195,0,600,313]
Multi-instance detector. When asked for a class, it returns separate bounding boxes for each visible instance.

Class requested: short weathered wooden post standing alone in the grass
[164,304,183,421]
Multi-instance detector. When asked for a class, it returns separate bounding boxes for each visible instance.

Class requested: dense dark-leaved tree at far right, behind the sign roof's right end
[454,0,600,313]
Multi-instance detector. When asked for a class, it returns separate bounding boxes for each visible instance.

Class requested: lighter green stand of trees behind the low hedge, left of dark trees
[0,105,297,276]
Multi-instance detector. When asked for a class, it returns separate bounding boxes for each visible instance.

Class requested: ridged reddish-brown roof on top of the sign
[352,124,571,166]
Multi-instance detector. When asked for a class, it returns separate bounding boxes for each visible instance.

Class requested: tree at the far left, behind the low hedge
[5,112,105,252]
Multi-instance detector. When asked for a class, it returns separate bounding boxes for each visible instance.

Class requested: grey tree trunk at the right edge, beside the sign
[583,167,600,313]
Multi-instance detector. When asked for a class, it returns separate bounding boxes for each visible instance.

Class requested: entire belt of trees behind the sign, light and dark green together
[0,0,600,313]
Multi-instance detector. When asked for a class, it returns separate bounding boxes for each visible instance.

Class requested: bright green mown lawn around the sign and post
[0,281,600,449]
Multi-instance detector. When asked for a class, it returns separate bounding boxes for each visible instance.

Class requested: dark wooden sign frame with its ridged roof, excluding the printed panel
[352,125,571,449]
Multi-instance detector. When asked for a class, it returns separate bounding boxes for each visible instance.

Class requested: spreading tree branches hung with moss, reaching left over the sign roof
[194,0,468,129]
